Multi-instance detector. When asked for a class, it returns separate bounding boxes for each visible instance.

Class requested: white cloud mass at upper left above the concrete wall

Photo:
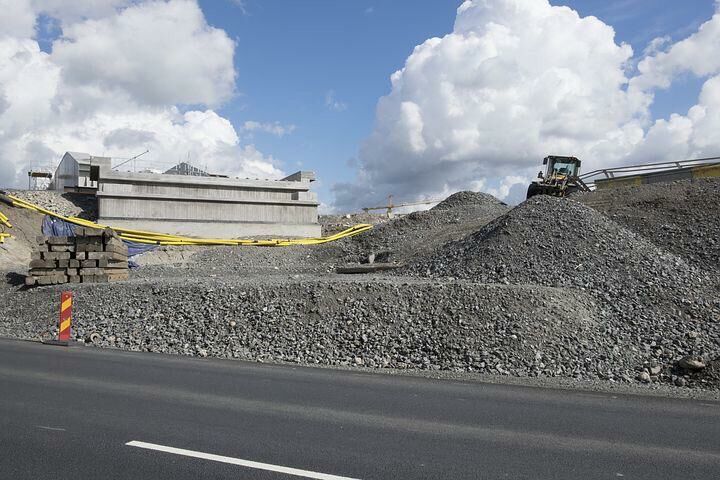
[0,0,282,185]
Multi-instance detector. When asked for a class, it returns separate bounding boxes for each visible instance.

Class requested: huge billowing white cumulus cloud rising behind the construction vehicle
[334,0,650,212]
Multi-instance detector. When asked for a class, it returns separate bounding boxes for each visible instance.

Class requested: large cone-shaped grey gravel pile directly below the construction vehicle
[404,196,720,382]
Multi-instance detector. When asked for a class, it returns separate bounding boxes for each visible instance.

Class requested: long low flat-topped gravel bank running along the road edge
[0,276,608,376]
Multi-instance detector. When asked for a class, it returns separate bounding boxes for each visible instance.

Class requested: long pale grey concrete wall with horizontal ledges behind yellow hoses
[97,170,320,238]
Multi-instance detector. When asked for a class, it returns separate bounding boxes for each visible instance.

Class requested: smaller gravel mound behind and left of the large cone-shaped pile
[320,192,510,263]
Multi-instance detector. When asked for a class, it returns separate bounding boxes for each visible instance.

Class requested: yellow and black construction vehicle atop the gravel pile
[527,155,590,198]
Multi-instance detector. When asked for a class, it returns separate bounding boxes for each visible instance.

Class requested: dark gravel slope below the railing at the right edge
[573,178,720,272]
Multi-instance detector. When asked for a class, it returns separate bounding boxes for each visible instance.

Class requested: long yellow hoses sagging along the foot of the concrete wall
[5,195,372,247]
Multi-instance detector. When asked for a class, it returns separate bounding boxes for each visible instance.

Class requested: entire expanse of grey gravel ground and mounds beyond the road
[0,181,720,392]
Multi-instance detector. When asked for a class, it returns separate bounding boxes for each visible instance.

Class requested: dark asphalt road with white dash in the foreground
[0,340,720,480]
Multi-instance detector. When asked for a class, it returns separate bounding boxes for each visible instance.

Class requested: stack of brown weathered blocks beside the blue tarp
[25,226,129,286]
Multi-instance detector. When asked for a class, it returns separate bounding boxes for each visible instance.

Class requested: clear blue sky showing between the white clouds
[194,0,714,206]
